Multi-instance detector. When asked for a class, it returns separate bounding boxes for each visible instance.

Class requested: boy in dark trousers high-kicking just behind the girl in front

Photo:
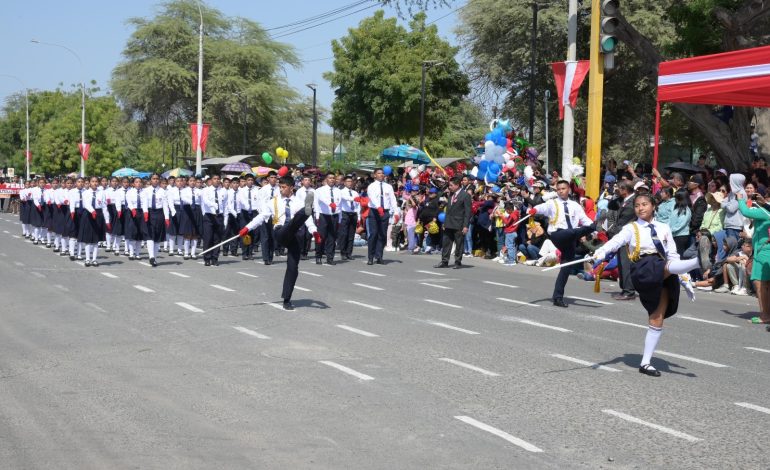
[527,180,596,307]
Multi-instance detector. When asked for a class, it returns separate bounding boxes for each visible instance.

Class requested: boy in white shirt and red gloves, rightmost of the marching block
[366,168,400,266]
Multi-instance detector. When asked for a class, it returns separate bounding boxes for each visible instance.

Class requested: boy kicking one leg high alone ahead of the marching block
[239,176,321,310]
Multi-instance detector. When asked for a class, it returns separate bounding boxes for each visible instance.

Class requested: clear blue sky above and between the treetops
[0,0,465,129]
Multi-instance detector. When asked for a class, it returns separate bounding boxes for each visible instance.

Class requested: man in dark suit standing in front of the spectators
[435,177,471,269]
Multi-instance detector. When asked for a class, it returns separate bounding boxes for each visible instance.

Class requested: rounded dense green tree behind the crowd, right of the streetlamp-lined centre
[324,11,469,143]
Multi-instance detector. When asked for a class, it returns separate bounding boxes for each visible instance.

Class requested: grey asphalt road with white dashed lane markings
[0,215,770,469]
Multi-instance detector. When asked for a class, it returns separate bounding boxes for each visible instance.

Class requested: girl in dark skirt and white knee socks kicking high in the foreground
[593,193,703,377]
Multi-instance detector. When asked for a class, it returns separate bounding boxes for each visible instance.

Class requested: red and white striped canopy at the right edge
[658,46,770,107]
